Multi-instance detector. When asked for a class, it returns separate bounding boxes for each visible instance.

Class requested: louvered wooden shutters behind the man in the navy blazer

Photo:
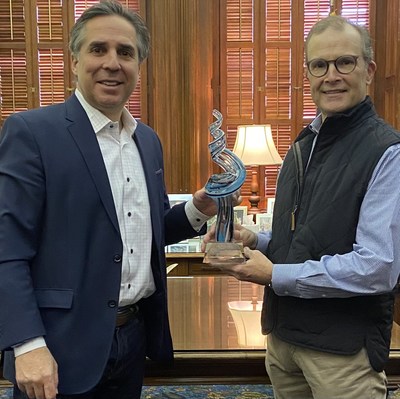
[0,0,146,126]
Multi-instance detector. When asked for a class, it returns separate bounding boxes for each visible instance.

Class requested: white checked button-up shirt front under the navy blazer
[76,90,155,306]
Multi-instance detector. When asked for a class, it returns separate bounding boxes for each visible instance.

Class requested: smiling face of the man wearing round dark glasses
[307,25,376,119]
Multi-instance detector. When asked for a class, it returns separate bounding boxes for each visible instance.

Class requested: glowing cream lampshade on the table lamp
[233,125,282,165]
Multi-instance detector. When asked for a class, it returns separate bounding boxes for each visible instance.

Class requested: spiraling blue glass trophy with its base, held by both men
[203,109,246,264]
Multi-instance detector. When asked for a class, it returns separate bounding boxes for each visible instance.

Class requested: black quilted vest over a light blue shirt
[262,97,400,371]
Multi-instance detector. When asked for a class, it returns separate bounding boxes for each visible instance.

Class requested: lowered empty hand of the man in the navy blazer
[15,347,58,399]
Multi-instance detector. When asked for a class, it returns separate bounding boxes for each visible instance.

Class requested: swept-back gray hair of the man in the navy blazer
[69,0,150,64]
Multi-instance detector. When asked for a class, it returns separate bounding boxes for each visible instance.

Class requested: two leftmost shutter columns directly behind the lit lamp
[221,0,291,200]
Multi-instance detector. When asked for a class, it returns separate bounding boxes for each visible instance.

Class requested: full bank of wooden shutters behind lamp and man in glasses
[220,0,369,203]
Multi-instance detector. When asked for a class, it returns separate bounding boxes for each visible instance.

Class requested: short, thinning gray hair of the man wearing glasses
[305,15,374,64]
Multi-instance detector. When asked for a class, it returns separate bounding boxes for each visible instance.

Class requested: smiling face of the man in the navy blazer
[72,15,139,121]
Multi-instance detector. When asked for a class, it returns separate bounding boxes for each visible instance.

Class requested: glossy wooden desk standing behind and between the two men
[160,253,400,389]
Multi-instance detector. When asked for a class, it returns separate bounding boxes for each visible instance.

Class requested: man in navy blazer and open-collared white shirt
[0,1,222,399]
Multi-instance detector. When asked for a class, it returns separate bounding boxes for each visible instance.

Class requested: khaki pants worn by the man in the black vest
[265,334,387,399]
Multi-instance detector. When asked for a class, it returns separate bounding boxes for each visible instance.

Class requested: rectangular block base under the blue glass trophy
[203,242,246,265]
